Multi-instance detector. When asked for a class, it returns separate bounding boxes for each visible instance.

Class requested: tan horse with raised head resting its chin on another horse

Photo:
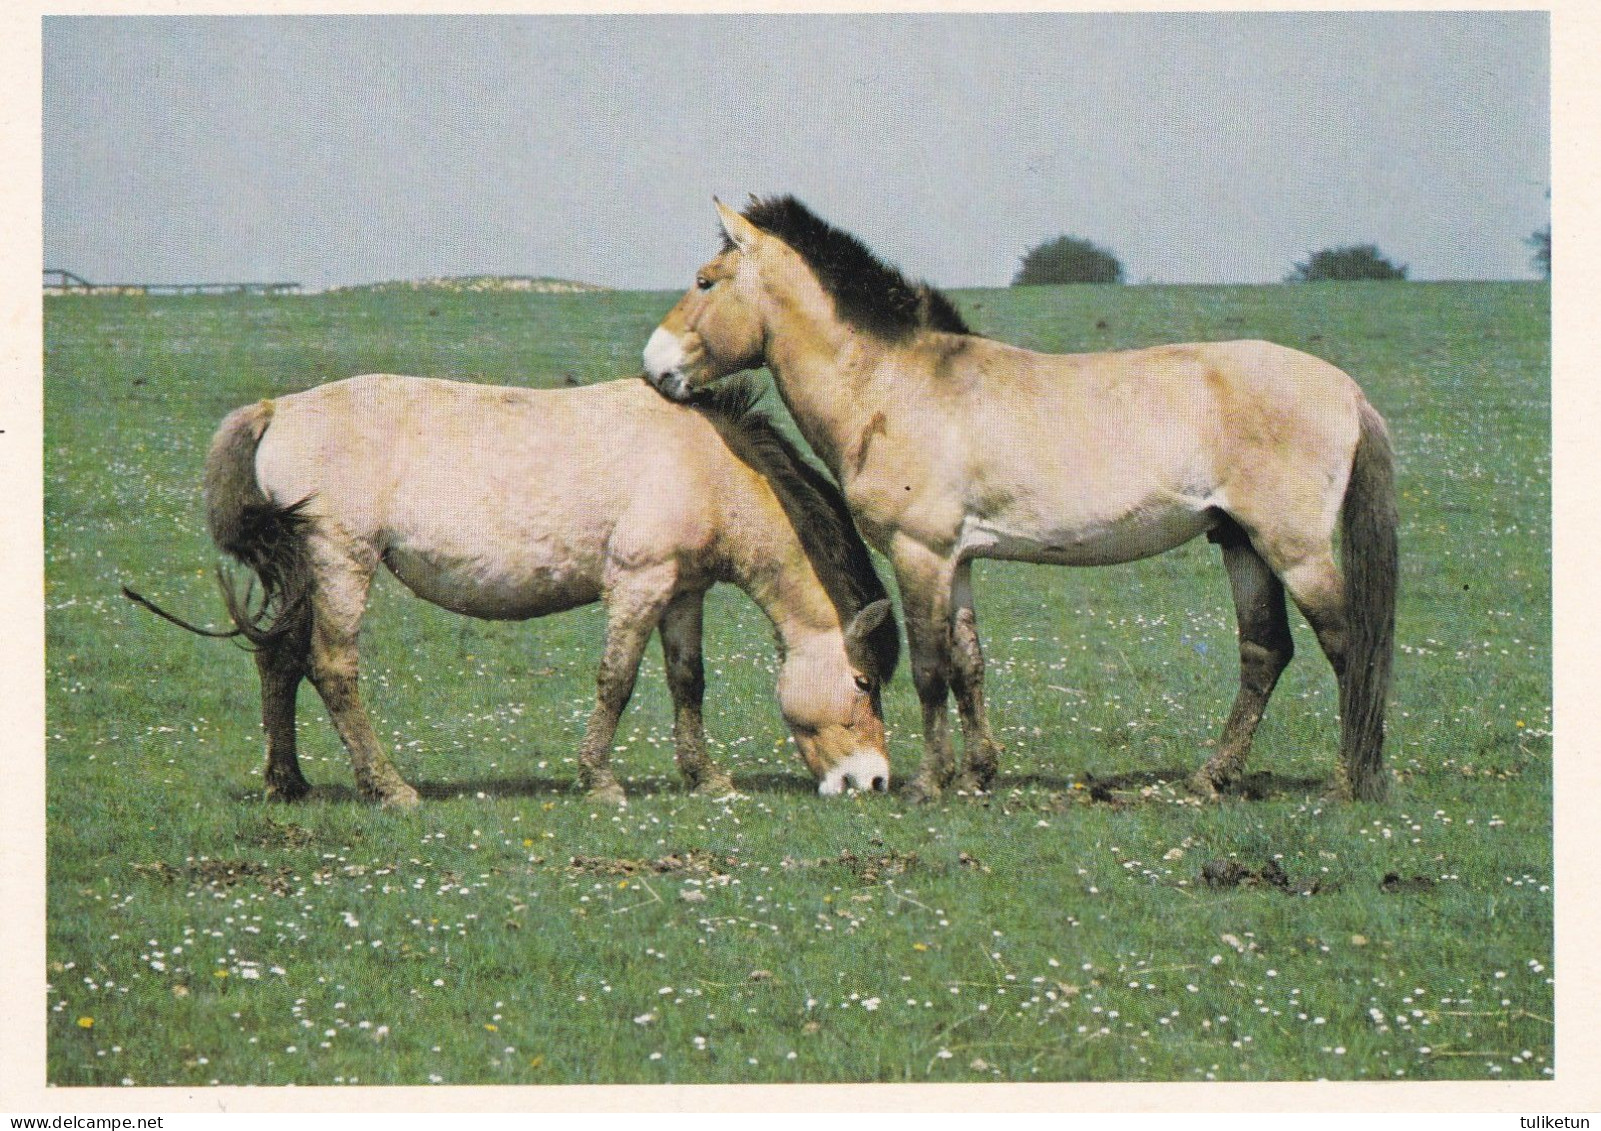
[645,197,1398,799]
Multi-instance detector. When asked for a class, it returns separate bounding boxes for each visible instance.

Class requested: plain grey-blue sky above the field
[43,13,1550,288]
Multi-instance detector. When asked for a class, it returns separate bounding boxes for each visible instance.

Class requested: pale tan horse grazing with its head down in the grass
[128,375,900,806]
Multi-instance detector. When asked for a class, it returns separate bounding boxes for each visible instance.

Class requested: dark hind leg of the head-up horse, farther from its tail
[1191,527,1295,796]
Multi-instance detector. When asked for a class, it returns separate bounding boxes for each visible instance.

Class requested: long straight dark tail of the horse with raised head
[1340,400,1401,801]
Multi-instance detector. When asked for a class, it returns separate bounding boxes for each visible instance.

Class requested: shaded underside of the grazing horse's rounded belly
[384,546,600,620]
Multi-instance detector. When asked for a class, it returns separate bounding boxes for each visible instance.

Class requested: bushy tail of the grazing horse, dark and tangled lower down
[205,400,312,647]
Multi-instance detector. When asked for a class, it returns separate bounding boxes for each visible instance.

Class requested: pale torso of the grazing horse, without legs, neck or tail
[256,375,733,618]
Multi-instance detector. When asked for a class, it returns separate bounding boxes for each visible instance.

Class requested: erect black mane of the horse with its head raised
[744,195,972,341]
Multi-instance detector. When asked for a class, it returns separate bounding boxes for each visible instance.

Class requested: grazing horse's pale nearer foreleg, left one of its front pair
[578,564,676,806]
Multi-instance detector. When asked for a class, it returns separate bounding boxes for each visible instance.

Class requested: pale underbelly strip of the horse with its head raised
[961,508,1215,566]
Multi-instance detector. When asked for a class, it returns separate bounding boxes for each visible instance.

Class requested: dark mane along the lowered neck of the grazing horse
[693,380,900,682]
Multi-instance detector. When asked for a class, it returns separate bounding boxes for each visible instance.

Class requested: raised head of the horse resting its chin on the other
[645,200,781,400]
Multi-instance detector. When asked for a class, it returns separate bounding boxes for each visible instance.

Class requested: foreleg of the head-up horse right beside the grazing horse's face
[890,540,956,803]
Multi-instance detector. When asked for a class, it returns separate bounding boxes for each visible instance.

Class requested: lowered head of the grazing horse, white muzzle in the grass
[778,598,898,796]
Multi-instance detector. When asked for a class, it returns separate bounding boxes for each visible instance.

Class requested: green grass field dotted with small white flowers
[45,284,1556,1086]
